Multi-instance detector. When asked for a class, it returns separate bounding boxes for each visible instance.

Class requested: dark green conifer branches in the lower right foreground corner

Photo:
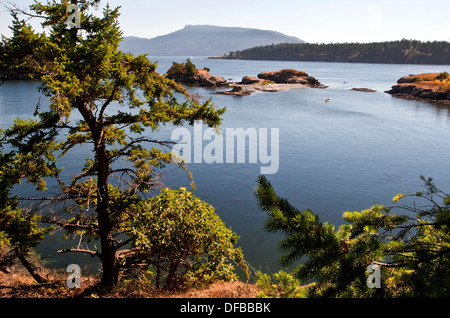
[255,176,450,297]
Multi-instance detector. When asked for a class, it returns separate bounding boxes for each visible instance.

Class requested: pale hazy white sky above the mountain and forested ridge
[0,0,450,43]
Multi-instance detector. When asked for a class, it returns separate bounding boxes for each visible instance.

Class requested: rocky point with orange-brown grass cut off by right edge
[386,72,450,104]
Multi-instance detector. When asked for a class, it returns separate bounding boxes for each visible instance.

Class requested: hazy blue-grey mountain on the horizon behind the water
[120,25,305,56]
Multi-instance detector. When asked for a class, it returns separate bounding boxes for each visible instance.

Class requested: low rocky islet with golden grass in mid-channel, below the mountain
[165,59,326,96]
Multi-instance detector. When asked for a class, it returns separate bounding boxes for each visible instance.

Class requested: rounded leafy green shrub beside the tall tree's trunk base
[133,188,247,289]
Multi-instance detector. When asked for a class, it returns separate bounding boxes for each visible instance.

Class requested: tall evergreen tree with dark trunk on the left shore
[0,0,225,287]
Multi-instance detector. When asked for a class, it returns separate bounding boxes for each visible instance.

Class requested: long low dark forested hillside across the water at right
[223,40,450,64]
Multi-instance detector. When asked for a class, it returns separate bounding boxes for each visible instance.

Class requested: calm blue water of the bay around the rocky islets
[0,57,450,271]
